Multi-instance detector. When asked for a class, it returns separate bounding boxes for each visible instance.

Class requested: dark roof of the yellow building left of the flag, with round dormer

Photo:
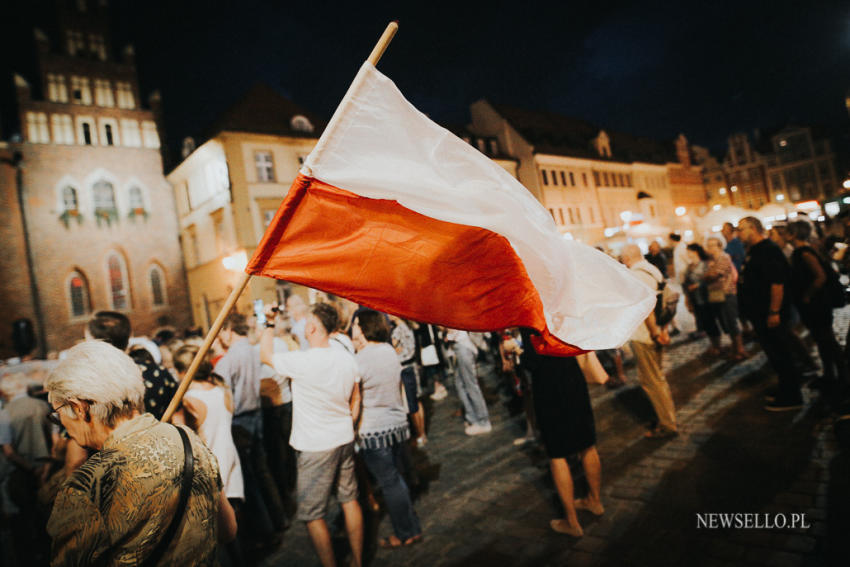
[198,83,327,145]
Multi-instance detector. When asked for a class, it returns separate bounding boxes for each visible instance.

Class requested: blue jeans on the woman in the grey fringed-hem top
[360,443,422,542]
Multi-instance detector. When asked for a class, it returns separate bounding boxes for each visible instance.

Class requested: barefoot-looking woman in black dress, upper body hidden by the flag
[522,330,605,537]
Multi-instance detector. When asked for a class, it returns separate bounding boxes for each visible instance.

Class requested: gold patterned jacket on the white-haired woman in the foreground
[47,413,221,566]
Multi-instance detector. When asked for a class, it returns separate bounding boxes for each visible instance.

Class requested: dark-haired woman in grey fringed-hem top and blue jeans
[351,311,422,547]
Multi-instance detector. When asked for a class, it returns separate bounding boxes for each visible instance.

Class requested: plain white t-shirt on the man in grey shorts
[272,347,360,451]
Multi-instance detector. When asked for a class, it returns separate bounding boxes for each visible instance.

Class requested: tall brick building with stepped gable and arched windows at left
[0,2,191,354]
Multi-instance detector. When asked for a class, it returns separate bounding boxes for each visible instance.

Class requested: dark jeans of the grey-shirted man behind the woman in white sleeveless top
[231,409,285,540]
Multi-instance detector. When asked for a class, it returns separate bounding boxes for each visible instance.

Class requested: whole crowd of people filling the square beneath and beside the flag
[0,217,850,565]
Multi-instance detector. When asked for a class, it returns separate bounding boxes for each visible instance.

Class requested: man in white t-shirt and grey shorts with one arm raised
[260,303,363,566]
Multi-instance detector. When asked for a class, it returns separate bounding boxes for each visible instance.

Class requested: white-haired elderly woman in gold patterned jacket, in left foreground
[46,341,236,565]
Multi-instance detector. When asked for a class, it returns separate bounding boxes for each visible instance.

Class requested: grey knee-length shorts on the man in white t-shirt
[295,441,357,522]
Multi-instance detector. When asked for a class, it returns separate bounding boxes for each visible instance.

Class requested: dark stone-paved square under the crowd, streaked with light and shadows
[263,318,850,566]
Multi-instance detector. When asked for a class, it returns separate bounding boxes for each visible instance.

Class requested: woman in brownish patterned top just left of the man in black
[703,235,747,360]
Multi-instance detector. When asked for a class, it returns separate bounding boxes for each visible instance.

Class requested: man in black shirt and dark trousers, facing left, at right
[738,217,803,411]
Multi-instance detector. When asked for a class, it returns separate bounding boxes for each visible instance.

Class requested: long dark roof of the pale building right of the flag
[490,103,677,164]
